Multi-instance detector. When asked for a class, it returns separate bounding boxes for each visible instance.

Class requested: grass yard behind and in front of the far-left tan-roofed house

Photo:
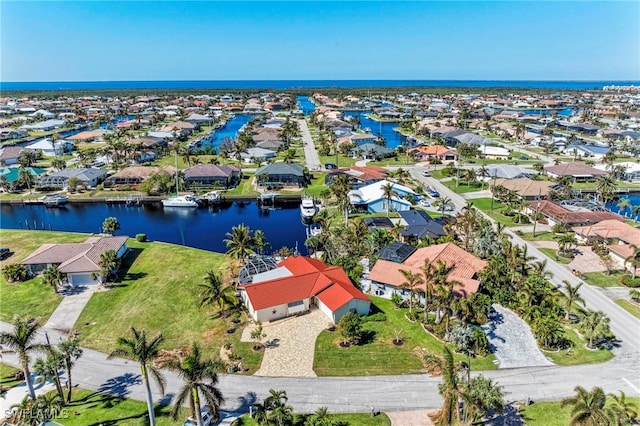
[0,229,89,324]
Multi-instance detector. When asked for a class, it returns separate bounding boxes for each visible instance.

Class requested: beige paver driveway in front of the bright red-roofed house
[241,309,331,377]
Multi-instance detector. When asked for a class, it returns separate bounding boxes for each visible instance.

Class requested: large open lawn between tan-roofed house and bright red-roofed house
[76,240,262,373]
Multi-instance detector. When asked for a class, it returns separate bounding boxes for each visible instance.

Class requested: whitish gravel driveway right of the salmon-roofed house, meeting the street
[482,304,553,368]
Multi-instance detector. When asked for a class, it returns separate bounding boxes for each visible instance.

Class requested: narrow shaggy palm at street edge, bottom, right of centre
[425,346,461,425]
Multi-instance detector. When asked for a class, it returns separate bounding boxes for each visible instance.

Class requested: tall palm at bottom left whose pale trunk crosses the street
[107,327,164,426]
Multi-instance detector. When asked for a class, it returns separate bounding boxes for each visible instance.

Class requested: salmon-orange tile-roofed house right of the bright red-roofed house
[368,243,487,302]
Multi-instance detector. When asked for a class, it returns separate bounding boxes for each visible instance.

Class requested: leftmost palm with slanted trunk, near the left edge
[0,315,45,400]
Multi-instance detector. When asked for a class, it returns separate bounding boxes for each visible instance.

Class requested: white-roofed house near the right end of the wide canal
[349,180,417,213]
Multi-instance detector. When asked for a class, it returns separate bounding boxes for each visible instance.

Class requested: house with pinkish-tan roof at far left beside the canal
[20,237,129,287]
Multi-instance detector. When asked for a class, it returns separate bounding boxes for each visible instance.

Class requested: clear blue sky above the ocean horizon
[0,0,640,81]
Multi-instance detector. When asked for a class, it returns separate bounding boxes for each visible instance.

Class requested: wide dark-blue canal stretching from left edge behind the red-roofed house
[0,202,306,254]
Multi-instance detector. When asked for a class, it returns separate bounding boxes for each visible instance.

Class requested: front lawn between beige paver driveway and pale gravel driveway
[313,296,496,376]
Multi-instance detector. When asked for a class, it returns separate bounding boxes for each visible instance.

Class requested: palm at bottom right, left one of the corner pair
[560,386,609,426]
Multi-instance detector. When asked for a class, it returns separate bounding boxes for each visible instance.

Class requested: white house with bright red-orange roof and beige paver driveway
[238,256,371,323]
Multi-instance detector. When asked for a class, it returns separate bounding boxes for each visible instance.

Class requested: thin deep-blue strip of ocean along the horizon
[0,80,640,91]
